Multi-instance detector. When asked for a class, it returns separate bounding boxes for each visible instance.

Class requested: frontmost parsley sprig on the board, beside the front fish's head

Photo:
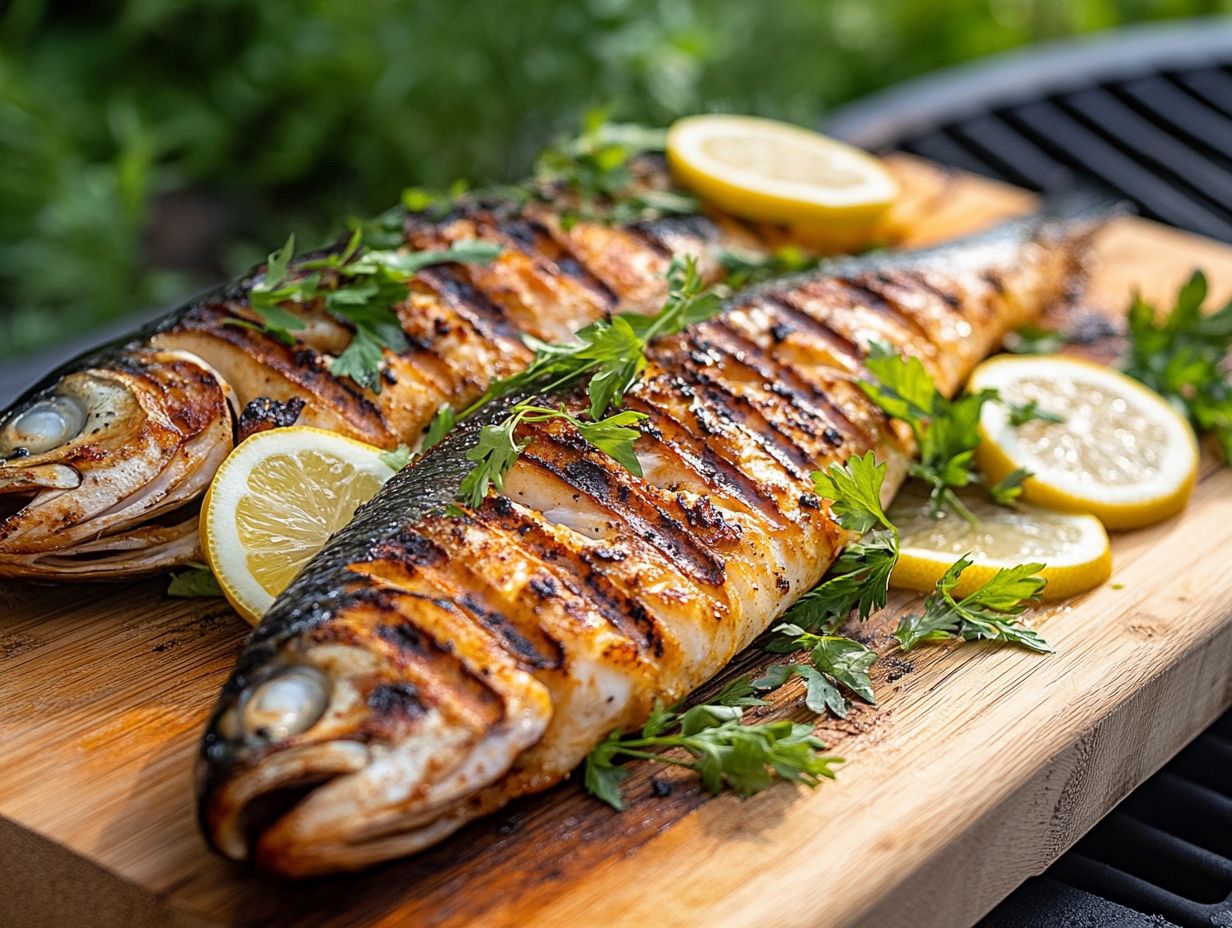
[583,679,840,811]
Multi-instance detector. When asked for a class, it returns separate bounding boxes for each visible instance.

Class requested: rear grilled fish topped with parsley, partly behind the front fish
[0,159,766,579]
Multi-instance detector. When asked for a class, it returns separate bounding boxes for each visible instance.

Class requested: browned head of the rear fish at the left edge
[0,349,234,578]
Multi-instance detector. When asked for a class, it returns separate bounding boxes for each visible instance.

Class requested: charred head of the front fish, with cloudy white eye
[197,586,552,876]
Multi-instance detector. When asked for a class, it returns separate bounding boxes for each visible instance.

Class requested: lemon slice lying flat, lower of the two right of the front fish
[890,489,1112,599]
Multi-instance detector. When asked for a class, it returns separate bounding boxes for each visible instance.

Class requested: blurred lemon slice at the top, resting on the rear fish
[668,116,898,248]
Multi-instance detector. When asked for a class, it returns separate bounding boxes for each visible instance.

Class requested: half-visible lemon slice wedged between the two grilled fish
[201,426,393,625]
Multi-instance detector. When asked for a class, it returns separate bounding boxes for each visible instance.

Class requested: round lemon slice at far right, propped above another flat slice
[970,355,1198,529]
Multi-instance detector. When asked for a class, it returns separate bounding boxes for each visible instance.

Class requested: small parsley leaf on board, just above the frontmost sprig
[753,622,877,718]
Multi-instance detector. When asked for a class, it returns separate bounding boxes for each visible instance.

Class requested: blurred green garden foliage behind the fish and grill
[0,0,1228,356]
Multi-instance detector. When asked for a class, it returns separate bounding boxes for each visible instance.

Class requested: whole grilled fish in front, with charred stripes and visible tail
[198,209,1090,876]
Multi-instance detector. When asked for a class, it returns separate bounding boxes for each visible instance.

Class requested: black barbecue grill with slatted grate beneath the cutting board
[827,18,1232,928]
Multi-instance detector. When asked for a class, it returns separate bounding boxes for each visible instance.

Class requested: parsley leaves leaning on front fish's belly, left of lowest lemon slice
[785,451,898,631]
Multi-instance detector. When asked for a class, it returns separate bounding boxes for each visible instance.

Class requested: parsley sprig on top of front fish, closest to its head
[458,401,646,505]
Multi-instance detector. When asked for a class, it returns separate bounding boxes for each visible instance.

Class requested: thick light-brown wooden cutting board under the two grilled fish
[0,161,1232,928]
